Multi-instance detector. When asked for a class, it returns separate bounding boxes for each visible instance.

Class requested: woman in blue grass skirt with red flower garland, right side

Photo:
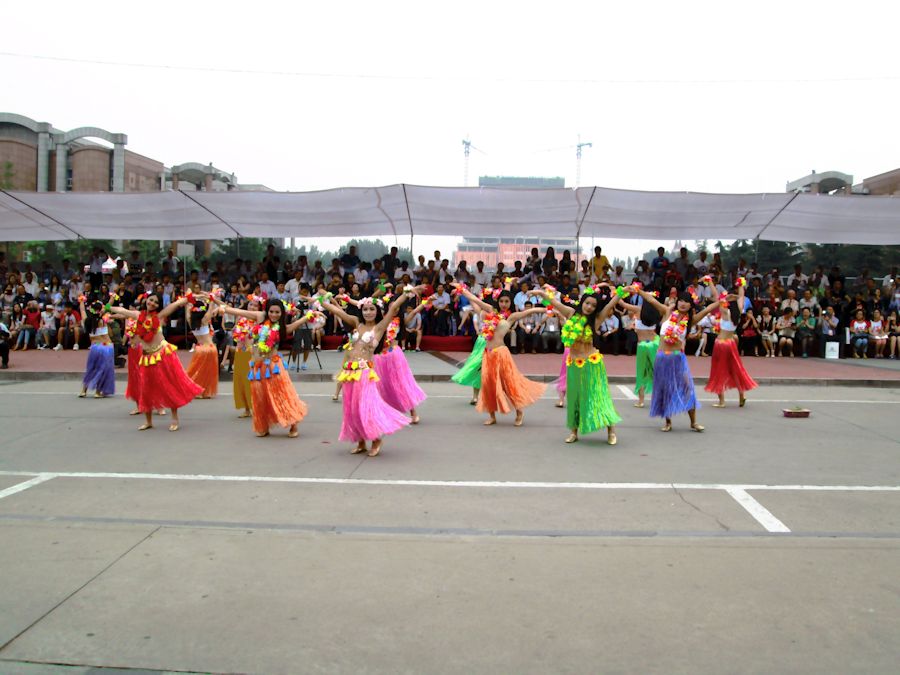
[626,286,719,431]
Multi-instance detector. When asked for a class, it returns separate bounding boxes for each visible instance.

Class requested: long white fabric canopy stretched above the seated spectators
[0,184,900,244]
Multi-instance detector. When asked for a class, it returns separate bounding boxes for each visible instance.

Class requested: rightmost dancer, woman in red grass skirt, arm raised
[705,277,757,408]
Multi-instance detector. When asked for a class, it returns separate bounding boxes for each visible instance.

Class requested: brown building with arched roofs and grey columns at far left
[0,113,165,192]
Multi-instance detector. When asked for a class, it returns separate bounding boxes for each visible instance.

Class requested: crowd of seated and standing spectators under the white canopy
[0,245,900,364]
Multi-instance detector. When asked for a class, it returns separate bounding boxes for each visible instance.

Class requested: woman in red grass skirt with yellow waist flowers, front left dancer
[110,293,203,431]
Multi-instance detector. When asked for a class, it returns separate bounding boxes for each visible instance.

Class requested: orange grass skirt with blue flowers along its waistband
[248,352,307,434]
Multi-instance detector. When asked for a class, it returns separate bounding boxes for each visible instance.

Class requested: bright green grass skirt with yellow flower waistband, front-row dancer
[566,354,622,434]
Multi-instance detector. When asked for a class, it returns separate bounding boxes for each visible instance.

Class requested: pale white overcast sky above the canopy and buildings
[0,0,900,256]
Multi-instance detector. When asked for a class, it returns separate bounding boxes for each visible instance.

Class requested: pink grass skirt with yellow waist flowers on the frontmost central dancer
[338,361,409,443]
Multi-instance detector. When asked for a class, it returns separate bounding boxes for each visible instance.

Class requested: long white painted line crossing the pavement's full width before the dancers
[0,471,900,496]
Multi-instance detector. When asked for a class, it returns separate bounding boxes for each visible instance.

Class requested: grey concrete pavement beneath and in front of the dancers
[0,378,900,675]
